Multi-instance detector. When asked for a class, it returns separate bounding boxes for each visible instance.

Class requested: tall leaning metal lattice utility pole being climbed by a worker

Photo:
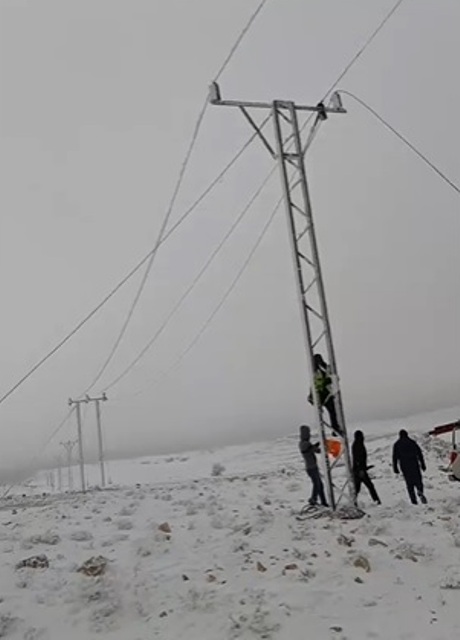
[209,82,357,517]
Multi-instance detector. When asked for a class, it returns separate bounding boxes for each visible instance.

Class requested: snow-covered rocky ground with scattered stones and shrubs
[0,418,460,640]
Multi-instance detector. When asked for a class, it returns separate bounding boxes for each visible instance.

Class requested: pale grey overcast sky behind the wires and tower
[0,0,460,466]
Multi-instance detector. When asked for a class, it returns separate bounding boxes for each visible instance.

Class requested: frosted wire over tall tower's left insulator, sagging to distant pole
[84,0,267,393]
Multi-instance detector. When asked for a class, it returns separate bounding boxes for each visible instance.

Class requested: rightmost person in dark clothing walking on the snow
[393,429,427,504]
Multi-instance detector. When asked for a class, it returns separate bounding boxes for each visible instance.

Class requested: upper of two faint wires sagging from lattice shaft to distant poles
[104,168,272,391]
